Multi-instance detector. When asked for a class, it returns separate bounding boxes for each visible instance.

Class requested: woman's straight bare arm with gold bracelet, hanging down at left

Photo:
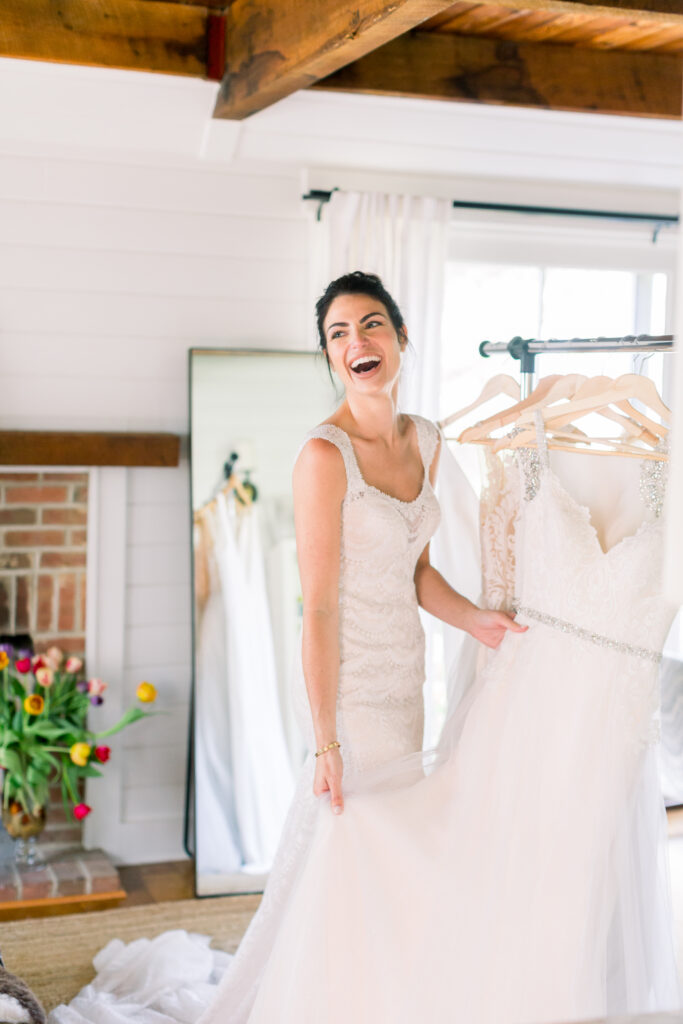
[293,438,346,813]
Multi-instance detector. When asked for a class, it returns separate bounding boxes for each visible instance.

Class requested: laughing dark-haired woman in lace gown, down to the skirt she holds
[294,271,523,813]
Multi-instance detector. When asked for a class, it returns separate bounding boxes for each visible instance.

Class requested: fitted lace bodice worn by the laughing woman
[301,416,440,767]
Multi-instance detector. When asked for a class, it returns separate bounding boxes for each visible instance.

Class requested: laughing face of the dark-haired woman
[323,295,407,394]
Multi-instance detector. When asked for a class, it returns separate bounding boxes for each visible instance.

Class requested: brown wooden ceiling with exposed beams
[0,0,683,120]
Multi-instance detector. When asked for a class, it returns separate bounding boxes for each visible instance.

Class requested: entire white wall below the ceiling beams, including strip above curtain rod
[0,51,683,862]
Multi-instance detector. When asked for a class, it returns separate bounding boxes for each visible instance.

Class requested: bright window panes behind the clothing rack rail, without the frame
[440,260,669,426]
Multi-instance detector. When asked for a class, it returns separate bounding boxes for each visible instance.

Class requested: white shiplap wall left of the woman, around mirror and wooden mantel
[0,128,308,863]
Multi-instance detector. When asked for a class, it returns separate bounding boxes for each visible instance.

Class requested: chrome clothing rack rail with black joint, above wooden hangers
[479,334,674,398]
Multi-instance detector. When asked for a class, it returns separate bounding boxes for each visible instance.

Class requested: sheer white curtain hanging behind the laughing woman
[325,191,480,746]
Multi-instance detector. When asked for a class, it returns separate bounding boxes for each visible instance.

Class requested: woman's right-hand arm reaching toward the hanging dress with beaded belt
[415,425,527,647]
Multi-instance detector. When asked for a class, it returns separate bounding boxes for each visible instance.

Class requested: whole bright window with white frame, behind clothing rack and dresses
[425,215,683,745]
